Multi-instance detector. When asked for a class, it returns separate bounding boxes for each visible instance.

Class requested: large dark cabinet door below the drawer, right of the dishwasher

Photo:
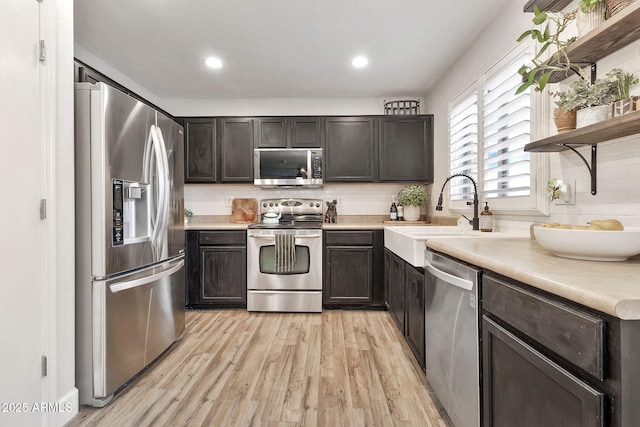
[482,316,604,427]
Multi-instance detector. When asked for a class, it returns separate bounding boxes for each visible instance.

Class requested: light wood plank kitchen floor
[68,310,450,427]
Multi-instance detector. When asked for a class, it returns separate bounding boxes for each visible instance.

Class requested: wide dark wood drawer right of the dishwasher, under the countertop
[482,275,605,380]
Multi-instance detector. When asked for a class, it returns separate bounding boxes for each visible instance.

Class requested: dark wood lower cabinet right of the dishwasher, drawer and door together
[482,272,640,427]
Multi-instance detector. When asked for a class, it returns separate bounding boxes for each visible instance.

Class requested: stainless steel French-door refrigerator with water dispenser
[75,83,185,407]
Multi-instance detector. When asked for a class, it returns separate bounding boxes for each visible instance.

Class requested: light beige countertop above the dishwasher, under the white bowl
[426,238,640,320]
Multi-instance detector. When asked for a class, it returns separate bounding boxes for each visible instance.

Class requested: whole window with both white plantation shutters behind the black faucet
[445,44,548,213]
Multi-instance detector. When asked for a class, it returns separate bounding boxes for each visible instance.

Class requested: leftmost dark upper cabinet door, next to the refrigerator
[184,119,217,183]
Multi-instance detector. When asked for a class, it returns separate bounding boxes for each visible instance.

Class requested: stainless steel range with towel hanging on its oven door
[247,199,323,312]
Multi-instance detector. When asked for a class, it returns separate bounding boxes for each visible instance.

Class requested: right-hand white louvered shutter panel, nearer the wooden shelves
[482,54,531,199]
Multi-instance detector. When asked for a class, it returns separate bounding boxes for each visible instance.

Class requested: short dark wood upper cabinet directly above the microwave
[255,116,322,148]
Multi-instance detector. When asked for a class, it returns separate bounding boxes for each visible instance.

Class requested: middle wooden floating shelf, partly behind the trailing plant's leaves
[549,1,640,83]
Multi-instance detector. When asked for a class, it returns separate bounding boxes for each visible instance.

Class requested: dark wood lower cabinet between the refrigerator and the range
[187,230,247,308]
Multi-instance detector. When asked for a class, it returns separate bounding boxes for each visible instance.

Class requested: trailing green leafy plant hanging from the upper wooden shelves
[516,6,582,94]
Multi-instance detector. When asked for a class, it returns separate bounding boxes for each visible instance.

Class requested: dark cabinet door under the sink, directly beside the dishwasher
[404,264,425,369]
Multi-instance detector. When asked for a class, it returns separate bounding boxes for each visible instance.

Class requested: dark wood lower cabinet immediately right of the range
[322,230,384,308]
